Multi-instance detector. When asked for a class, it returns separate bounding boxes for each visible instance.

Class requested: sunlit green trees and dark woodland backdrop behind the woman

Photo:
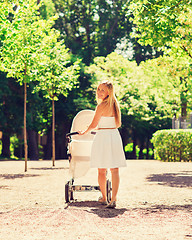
[0,0,192,170]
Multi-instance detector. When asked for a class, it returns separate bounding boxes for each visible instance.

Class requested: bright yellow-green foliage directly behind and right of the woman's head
[87,53,172,121]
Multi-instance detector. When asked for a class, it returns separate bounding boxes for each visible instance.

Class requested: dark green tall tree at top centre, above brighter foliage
[53,0,134,65]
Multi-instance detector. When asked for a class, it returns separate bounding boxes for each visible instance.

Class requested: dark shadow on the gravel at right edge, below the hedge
[147,171,192,188]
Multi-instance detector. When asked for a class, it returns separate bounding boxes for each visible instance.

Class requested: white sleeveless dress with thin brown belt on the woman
[90,117,126,168]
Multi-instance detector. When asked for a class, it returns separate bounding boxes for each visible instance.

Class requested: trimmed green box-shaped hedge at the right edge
[151,129,192,162]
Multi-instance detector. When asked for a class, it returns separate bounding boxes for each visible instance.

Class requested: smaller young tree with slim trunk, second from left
[35,39,79,166]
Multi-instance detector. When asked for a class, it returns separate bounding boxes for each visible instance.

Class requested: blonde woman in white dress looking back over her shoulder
[79,81,126,208]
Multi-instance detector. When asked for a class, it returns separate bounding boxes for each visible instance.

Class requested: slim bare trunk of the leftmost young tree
[24,82,28,172]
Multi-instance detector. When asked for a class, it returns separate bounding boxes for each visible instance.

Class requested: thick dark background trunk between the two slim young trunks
[27,130,39,160]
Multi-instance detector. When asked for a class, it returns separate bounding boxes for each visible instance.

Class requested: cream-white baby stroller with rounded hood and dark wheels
[65,110,112,203]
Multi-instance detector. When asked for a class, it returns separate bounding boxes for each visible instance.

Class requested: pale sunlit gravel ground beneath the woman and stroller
[0,160,192,240]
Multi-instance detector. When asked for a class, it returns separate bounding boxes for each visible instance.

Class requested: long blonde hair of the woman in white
[96,81,121,127]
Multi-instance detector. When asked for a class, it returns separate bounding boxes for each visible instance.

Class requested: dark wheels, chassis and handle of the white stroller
[65,132,112,203]
